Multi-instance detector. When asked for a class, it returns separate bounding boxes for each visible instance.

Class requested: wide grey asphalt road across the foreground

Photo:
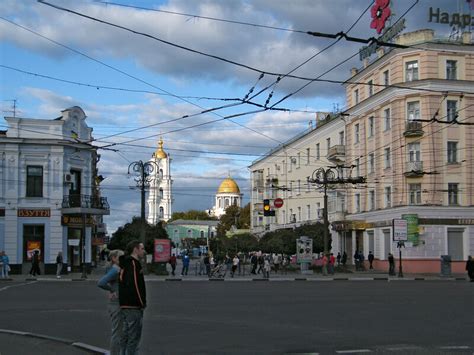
[0,281,474,354]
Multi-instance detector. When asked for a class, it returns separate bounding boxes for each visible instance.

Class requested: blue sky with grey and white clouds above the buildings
[0,0,468,233]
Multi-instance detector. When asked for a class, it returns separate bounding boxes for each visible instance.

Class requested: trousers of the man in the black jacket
[121,308,143,355]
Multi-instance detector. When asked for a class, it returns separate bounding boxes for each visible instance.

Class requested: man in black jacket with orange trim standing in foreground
[119,240,146,354]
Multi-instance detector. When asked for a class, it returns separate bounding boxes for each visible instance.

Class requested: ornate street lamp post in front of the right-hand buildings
[307,166,365,255]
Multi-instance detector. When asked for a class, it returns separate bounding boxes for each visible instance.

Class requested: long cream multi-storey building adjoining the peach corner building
[250,113,346,247]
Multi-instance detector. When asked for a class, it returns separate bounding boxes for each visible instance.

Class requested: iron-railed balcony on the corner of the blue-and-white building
[62,195,110,215]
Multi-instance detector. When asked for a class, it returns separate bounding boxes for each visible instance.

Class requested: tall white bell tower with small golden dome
[147,139,173,224]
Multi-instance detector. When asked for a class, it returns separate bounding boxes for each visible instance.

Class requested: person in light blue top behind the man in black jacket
[97,249,123,355]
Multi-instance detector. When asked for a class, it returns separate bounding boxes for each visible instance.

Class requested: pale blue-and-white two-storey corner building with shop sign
[0,107,110,273]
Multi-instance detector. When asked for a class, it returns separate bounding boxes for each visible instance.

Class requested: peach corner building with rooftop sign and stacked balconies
[340,30,474,272]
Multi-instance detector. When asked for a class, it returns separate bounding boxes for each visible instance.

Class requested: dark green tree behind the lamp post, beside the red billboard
[108,217,169,254]
